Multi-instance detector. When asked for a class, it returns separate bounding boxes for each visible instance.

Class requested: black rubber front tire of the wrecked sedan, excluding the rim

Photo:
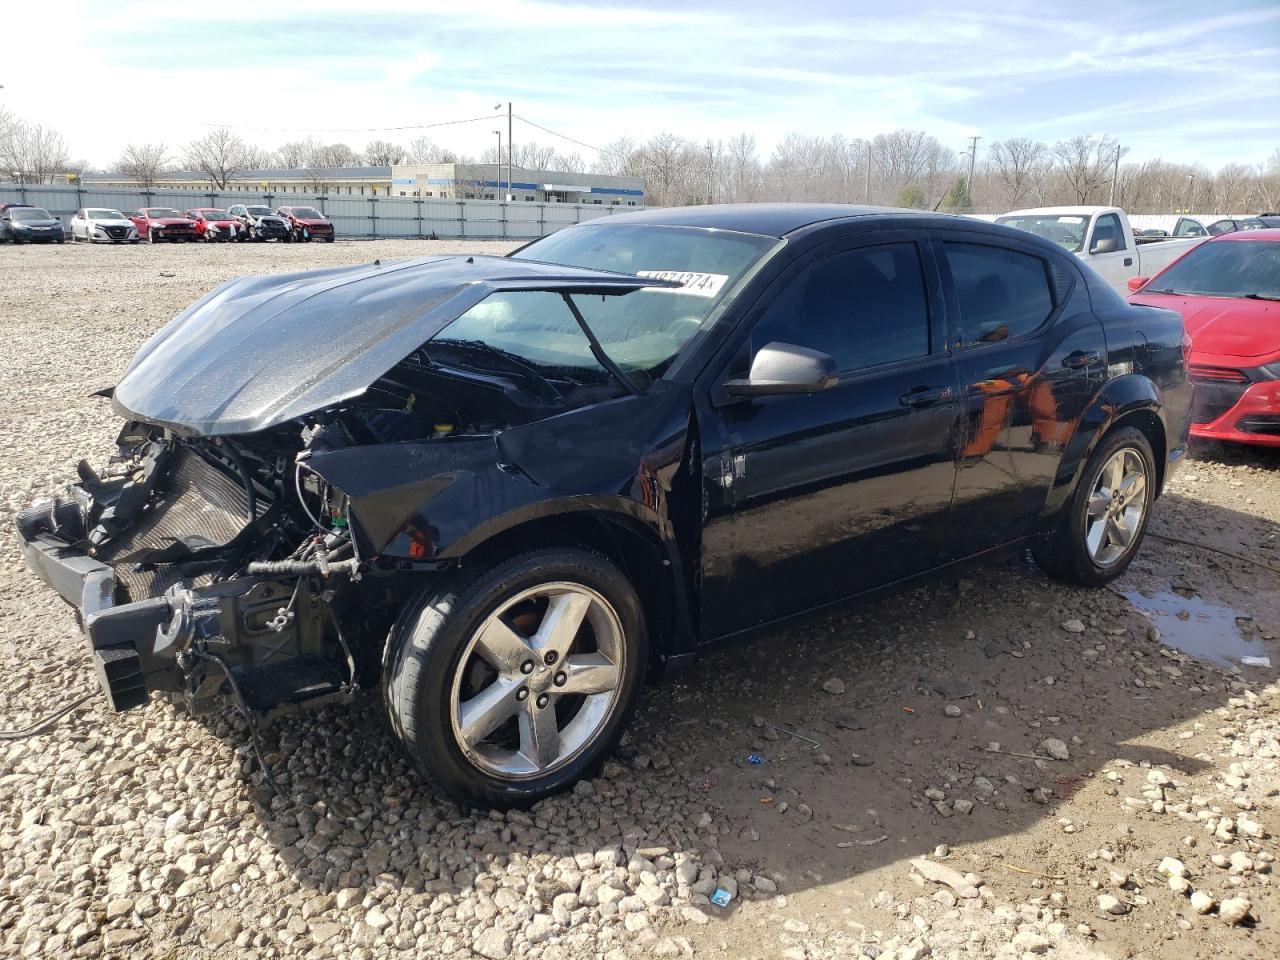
[383,549,648,808]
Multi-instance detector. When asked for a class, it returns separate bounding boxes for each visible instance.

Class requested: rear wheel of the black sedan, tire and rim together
[1032,426,1156,586]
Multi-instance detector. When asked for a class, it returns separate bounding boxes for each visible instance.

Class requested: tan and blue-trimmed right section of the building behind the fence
[392,164,644,206]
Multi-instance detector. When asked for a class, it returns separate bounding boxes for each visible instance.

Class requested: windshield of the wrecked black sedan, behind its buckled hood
[429,225,777,380]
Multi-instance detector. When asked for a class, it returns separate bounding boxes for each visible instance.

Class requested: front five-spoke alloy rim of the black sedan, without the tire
[449,582,626,780]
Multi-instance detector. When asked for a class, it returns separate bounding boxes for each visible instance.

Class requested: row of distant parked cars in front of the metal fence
[0,204,334,243]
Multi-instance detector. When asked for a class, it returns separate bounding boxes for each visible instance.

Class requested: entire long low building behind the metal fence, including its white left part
[79,164,645,206]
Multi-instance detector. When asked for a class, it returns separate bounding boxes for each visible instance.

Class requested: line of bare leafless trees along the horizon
[0,109,1280,214]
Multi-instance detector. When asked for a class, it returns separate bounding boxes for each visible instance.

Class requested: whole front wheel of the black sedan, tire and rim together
[383,549,648,808]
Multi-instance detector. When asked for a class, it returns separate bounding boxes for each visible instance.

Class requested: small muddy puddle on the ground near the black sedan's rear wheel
[1121,590,1276,667]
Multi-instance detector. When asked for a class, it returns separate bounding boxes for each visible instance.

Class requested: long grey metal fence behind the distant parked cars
[0,183,643,239]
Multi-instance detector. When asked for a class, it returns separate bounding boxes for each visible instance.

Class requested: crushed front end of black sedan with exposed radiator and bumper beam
[17,422,371,714]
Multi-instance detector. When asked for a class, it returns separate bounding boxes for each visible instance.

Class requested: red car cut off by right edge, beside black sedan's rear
[1129,229,1280,447]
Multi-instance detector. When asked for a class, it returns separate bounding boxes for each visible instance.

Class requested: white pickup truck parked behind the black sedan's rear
[996,206,1206,297]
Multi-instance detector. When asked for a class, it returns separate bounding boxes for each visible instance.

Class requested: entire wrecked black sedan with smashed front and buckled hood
[18,205,1189,806]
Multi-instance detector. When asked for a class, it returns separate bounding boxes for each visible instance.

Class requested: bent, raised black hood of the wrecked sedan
[113,256,676,436]
